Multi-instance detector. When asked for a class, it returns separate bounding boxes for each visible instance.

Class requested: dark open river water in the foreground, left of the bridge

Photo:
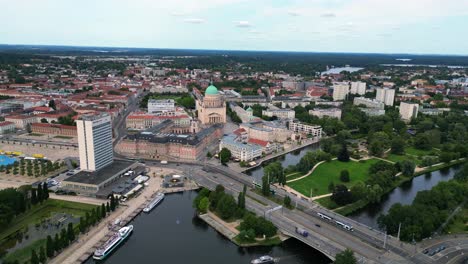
[85,192,330,264]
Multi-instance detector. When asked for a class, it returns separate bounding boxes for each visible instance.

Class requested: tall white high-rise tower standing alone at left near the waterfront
[76,113,114,171]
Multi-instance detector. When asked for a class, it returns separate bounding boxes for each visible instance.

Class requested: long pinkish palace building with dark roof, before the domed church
[115,124,223,161]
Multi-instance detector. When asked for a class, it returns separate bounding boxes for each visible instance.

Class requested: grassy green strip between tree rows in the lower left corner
[0,199,96,241]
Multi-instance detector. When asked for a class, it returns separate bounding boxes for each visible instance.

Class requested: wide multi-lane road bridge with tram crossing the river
[180,164,468,264]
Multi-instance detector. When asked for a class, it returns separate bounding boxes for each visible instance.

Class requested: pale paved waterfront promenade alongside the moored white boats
[49,169,166,264]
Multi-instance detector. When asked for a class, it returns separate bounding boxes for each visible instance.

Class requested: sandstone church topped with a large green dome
[196,85,226,125]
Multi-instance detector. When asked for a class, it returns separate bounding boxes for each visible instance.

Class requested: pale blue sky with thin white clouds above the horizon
[0,0,468,55]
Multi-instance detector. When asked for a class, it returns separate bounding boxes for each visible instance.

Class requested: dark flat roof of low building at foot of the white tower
[64,160,135,185]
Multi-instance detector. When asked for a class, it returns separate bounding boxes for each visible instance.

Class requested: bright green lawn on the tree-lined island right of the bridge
[288,159,379,196]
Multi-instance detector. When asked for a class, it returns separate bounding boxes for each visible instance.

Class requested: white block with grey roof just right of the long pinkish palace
[219,135,262,161]
